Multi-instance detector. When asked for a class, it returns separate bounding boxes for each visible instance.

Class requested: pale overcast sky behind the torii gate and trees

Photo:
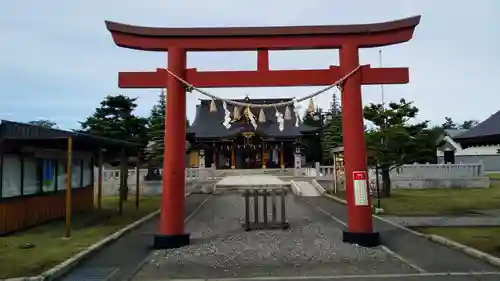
[0,0,500,129]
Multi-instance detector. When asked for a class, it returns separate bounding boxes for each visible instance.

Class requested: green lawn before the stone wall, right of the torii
[328,185,500,216]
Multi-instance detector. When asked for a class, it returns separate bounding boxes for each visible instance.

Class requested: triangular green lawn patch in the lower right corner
[415,227,500,257]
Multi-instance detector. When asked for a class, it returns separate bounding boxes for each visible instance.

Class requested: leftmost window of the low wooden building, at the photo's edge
[1,154,21,198]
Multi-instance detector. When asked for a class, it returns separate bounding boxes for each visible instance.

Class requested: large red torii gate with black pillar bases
[106,16,420,248]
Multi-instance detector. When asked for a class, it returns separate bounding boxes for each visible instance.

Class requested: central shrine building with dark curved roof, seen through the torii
[187,97,320,169]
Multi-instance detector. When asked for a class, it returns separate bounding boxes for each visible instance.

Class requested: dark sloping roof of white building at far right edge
[453,110,500,146]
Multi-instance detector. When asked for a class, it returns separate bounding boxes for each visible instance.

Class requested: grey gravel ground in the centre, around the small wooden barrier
[134,194,415,280]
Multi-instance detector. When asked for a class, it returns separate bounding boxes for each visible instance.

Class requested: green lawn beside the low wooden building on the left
[0,197,161,278]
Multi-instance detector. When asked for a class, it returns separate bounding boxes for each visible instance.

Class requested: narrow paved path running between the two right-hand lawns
[384,216,500,227]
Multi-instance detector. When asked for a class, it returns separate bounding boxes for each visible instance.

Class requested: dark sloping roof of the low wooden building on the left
[0,120,141,152]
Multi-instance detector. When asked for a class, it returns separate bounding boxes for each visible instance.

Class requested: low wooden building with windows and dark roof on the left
[0,121,137,235]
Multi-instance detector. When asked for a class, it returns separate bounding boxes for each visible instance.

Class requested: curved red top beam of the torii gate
[106,16,420,52]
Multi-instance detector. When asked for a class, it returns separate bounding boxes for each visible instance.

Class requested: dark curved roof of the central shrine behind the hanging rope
[188,98,319,138]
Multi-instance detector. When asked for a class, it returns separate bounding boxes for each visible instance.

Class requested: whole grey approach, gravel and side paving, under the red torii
[58,176,500,281]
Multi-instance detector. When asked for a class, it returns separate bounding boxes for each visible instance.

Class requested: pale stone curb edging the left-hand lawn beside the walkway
[4,193,191,281]
